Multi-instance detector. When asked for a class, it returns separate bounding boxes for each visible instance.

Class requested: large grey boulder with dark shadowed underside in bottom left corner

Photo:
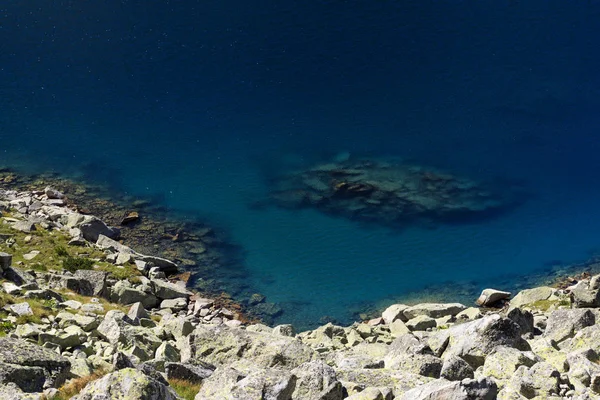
[0,337,71,391]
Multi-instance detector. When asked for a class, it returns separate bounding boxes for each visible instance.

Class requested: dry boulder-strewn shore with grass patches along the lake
[0,187,600,400]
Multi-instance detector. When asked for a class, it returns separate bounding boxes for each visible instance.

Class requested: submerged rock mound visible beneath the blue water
[270,159,514,226]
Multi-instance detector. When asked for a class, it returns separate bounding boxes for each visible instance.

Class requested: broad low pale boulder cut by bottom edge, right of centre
[400,378,498,400]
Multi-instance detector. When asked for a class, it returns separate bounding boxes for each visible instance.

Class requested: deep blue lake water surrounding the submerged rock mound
[0,0,600,326]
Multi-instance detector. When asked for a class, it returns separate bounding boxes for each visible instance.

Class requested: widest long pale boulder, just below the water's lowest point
[178,325,316,369]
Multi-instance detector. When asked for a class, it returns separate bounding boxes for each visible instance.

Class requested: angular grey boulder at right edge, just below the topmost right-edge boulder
[544,308,596,343]
